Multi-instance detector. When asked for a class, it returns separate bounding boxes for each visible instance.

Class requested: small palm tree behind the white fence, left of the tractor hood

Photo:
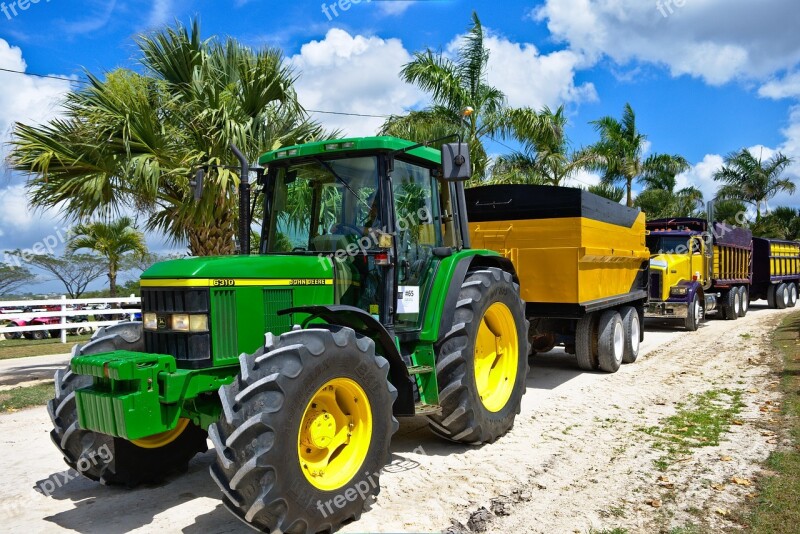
[67,217,147,298]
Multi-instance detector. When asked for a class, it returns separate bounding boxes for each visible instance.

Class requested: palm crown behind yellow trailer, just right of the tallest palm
[492,106,591,186]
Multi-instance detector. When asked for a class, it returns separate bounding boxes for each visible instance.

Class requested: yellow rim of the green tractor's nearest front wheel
[297,378,372,491]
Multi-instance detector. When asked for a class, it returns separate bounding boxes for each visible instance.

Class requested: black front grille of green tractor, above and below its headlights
[142,288,212,369]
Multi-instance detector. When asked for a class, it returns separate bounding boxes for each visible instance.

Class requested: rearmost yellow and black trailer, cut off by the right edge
[750,237,800,309]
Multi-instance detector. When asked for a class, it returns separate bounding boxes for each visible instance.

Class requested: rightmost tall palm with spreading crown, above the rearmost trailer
[714,148,795,222]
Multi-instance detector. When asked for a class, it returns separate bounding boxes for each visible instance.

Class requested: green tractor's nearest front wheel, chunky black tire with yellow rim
[209,326,398,533]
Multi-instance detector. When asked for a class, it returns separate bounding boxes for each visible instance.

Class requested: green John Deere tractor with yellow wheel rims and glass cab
[48,137,529,532]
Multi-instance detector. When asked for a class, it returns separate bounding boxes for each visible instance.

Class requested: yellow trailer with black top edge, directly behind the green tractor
[466,185,650,372]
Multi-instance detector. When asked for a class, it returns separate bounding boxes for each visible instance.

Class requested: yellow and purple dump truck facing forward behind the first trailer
[645,218,753,331]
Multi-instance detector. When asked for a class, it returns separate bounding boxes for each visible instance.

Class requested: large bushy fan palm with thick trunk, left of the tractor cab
[10,20,327,255]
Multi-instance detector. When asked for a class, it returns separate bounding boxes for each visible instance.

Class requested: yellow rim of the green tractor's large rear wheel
[475,302,519,412]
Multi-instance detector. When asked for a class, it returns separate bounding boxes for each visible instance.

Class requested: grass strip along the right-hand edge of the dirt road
[749,313,800,534]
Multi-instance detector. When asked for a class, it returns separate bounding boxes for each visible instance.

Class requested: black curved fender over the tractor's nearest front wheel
[278,305,415,416]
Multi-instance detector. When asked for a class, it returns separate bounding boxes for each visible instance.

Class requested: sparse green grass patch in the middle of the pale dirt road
[643,389,744,471]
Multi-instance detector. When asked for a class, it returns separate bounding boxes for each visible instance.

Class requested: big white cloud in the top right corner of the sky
[532,0,800,85]
